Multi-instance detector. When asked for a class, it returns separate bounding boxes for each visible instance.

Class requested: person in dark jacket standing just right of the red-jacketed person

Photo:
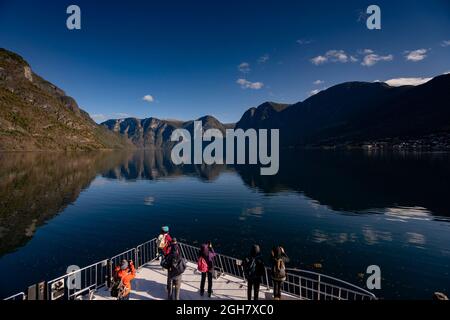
[166,238,186,300]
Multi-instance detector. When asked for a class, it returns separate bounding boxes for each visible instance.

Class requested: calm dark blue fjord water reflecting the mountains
[0,150,450,299]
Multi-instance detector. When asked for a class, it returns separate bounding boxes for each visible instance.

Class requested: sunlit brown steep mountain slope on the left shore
[0,48,132,151]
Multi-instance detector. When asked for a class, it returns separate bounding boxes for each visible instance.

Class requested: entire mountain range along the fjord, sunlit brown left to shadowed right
[0,49,450,150]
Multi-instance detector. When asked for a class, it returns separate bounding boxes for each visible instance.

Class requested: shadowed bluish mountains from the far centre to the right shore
[102,74,450,148]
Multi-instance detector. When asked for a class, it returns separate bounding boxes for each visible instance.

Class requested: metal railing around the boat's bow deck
[5,238,376,300]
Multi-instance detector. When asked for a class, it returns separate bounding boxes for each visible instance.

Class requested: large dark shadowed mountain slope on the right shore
[236,75,450,146]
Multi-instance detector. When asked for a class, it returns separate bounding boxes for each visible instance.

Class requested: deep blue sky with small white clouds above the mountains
[0,0,450,122]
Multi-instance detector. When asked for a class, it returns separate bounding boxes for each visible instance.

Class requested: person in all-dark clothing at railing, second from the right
[242,244,265,300]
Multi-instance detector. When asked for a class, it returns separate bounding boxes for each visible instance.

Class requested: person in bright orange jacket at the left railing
[111,260,136,300]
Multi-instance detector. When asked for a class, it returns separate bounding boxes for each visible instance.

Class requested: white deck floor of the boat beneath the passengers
[94,262,288,300]
